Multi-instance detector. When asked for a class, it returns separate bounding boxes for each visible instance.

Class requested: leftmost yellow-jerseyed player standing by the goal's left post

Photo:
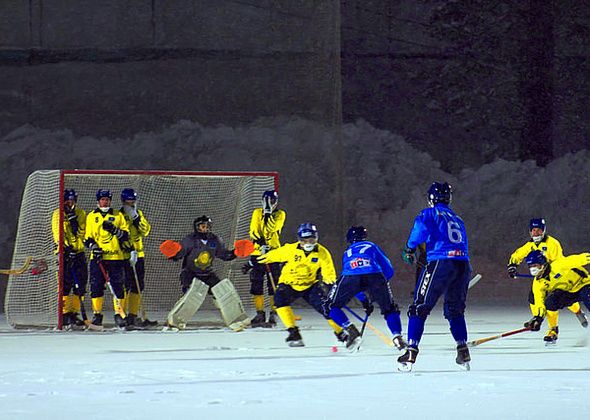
[51,189,88,328]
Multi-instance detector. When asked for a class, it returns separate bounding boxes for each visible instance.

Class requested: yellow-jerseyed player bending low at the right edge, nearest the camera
[526,250,590,343]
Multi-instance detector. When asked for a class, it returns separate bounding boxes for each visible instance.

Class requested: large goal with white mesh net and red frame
[4,170,278,328]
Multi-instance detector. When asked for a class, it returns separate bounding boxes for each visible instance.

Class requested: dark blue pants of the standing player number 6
[408,259,471,347]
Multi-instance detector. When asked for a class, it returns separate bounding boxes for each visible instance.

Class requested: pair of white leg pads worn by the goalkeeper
[167,277,250,331]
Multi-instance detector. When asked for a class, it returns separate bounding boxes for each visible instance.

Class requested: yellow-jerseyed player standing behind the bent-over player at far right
[507,218,588,328]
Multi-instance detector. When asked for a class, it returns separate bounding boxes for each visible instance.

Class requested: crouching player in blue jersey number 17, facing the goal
[326,226,405,351]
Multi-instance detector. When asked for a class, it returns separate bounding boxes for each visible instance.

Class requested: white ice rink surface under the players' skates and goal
[0,305,590,420]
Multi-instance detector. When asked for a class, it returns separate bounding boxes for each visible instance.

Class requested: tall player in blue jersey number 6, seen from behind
[397,182,471,370]
